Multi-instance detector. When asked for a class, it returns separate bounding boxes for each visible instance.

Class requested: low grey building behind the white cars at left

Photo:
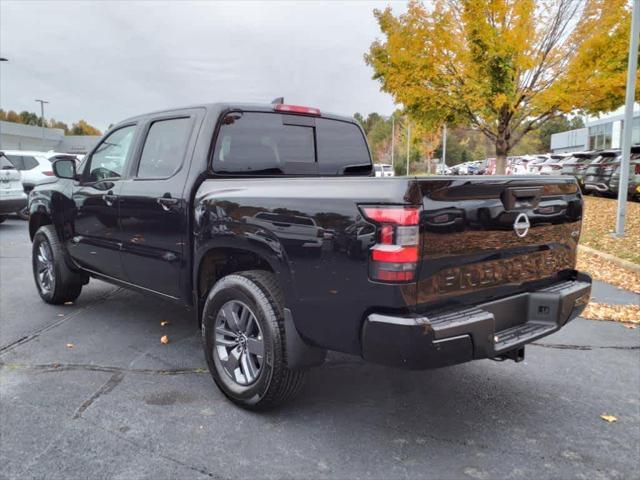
[0,120,100,154]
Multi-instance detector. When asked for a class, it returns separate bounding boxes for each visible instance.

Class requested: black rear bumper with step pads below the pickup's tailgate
[362,273,591,369]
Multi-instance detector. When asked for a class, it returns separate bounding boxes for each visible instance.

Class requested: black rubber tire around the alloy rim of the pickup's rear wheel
[202,270,306,410]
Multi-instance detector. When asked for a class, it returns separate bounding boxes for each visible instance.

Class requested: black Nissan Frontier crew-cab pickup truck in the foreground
[29,103,591,409]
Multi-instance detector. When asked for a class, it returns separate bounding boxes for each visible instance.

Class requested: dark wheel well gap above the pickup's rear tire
[198,248,273,298]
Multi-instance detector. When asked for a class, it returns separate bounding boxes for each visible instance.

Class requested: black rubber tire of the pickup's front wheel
[31,225,87,305]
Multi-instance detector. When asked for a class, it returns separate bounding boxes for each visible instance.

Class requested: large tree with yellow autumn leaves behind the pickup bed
[365,0,630,173]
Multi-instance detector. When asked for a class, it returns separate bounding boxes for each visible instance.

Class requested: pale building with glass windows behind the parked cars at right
[551,112,640,153]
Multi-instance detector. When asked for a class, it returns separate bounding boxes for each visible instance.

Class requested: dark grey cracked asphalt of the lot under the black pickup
[0,220,640,479]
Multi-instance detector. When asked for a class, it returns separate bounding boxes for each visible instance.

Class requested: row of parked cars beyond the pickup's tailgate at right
[444,145,640,200]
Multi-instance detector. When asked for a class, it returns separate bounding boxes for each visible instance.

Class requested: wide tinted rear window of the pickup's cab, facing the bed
[213,112,371,176]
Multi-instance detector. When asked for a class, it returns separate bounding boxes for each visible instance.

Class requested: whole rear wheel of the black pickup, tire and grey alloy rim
[202,270,305,410]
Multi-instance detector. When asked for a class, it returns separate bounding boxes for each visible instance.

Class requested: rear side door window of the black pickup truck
[137,117,191,179]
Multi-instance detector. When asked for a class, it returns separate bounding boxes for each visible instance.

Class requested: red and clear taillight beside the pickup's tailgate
[362,206,420,283]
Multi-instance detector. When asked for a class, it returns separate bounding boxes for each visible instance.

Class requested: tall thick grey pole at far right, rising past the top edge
[616,0,640,237]
